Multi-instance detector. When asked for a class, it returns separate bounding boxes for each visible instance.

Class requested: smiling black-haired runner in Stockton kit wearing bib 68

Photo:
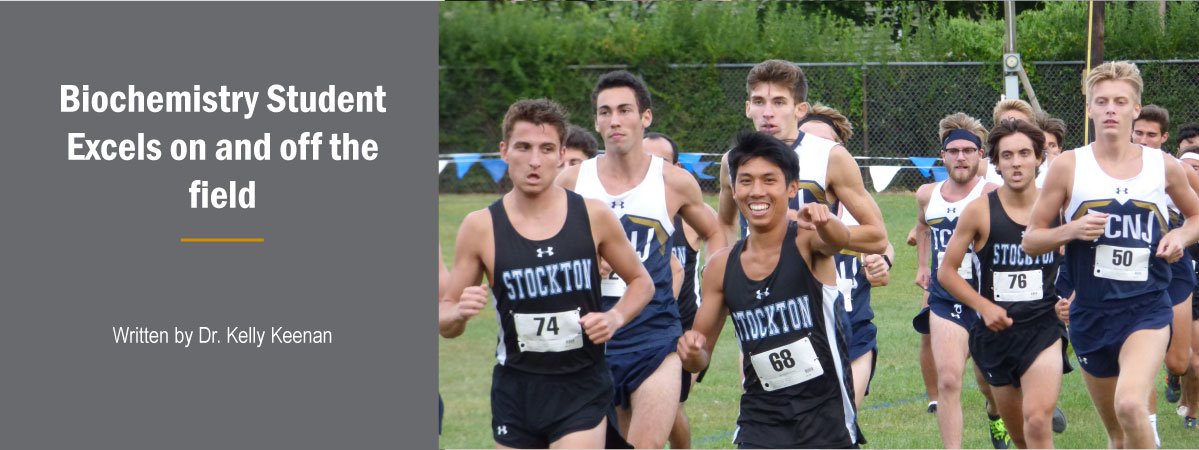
[679,132,864,449]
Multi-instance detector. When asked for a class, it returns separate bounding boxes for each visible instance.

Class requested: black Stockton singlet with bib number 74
[488,191,604,374]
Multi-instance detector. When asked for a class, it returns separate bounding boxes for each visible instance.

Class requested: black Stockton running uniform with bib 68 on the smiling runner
[724,222,860,448]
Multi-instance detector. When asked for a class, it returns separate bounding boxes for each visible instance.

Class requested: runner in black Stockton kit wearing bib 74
[439,100,653,449]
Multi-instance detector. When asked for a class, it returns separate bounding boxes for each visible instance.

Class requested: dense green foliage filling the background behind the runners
[438,1,1199,192]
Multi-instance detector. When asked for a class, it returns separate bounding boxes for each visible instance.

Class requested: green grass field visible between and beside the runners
[438,194,1199,449]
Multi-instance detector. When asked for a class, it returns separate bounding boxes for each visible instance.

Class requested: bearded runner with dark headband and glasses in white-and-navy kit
[914,113,1010,449]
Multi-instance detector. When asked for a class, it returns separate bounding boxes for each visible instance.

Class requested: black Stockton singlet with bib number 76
[976,191,1059,322]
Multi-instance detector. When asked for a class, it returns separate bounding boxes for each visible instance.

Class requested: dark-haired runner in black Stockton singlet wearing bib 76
[936,120,1068,449]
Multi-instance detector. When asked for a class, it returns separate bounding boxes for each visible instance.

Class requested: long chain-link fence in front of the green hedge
[440,61,1199,192]
